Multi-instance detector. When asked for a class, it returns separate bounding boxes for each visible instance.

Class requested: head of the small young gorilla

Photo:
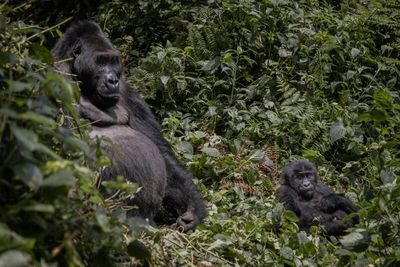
[282,160,318,199]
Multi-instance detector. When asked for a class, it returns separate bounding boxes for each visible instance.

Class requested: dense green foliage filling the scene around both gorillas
[0,0,400,266]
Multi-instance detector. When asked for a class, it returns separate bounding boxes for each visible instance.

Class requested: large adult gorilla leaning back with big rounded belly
[53,21,206,231]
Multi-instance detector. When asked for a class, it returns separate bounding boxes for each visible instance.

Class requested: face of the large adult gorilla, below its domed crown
[72,38,122,103]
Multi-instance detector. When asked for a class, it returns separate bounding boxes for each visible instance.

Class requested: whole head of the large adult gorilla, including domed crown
[54,21,122,108]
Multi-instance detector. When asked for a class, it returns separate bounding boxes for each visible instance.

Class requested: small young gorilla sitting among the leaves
[276,160,358,236]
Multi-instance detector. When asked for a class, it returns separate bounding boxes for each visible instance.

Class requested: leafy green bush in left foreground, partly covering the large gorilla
[0,5,148,266]
